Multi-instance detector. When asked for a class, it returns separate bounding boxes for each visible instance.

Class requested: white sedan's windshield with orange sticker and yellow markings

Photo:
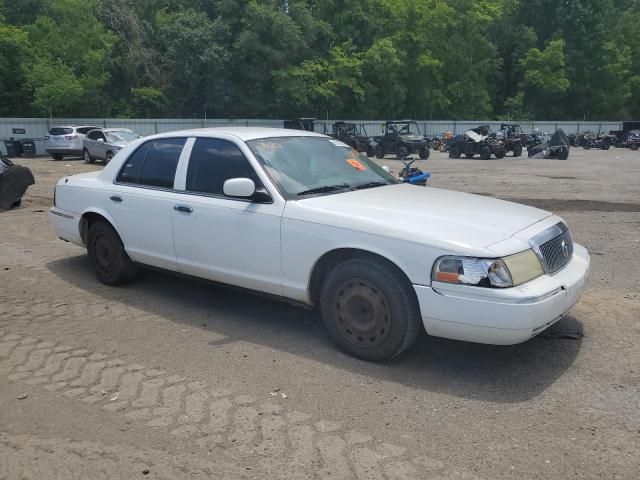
[247,137,397,199]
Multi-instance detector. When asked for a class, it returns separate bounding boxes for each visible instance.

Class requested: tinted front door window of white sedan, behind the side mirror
[186,138,262,195]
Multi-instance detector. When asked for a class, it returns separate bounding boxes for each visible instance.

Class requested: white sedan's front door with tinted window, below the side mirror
[173,134,284,295]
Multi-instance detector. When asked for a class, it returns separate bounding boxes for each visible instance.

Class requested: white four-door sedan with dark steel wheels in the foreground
[50,128,589,360]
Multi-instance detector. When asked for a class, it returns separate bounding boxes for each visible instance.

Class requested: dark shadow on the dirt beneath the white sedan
[47,255,582,403]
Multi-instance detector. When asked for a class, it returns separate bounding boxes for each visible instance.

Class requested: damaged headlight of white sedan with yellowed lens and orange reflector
[432,250,544,288]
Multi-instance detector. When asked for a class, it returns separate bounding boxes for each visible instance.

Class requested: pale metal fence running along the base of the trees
[0,118,622,155]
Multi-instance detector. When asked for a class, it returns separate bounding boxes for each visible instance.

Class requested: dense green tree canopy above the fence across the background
[0,0,640,120]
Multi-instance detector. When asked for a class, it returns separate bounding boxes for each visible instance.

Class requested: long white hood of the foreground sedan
[285,184,552,256]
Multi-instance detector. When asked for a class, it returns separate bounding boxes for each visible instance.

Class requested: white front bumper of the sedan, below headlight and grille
[414,243,590,345]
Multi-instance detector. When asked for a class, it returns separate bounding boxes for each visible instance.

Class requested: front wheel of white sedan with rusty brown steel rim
[320,258,422,361]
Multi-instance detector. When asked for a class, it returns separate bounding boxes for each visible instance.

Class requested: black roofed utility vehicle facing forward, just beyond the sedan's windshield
[374,120,430,160]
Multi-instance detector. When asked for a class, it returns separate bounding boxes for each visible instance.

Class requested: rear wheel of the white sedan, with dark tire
[87,221,138,286]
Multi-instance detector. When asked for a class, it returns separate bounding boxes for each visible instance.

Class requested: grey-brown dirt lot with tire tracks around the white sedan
[0,149,640,480]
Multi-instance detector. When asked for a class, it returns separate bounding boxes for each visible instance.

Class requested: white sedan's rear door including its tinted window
[105,137,187,270]
